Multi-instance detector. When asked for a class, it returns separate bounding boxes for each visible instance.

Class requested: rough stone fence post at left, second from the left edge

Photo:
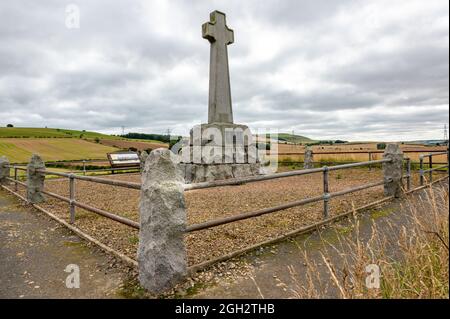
[27,154,45,204]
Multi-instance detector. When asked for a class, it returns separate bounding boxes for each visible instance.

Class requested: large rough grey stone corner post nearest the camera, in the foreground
[138,148,187,293]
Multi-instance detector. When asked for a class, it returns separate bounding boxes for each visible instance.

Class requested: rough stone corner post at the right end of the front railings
[383,144,403,198]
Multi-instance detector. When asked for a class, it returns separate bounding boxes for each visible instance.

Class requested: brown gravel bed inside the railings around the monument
[12,169,438,265]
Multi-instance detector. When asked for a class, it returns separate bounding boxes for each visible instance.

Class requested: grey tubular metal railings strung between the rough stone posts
[1,150,449,276]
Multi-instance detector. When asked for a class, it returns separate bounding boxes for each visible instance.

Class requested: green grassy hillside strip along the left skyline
[0,127,122,139]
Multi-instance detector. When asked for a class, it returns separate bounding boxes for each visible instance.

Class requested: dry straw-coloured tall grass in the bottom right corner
[284,186,449,299]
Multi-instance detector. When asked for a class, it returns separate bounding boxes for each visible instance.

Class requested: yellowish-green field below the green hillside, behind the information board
[0,138,118,163]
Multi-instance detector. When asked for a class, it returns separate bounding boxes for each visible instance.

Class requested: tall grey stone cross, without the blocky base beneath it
[202,11,234,123]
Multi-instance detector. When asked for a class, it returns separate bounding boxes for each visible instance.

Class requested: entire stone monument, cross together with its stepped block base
[181,11,260,183]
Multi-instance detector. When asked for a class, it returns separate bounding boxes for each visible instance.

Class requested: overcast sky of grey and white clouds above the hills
[0,0,449,140]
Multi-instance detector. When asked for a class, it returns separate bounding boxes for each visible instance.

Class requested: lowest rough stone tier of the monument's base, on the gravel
[180,163,260,183]
